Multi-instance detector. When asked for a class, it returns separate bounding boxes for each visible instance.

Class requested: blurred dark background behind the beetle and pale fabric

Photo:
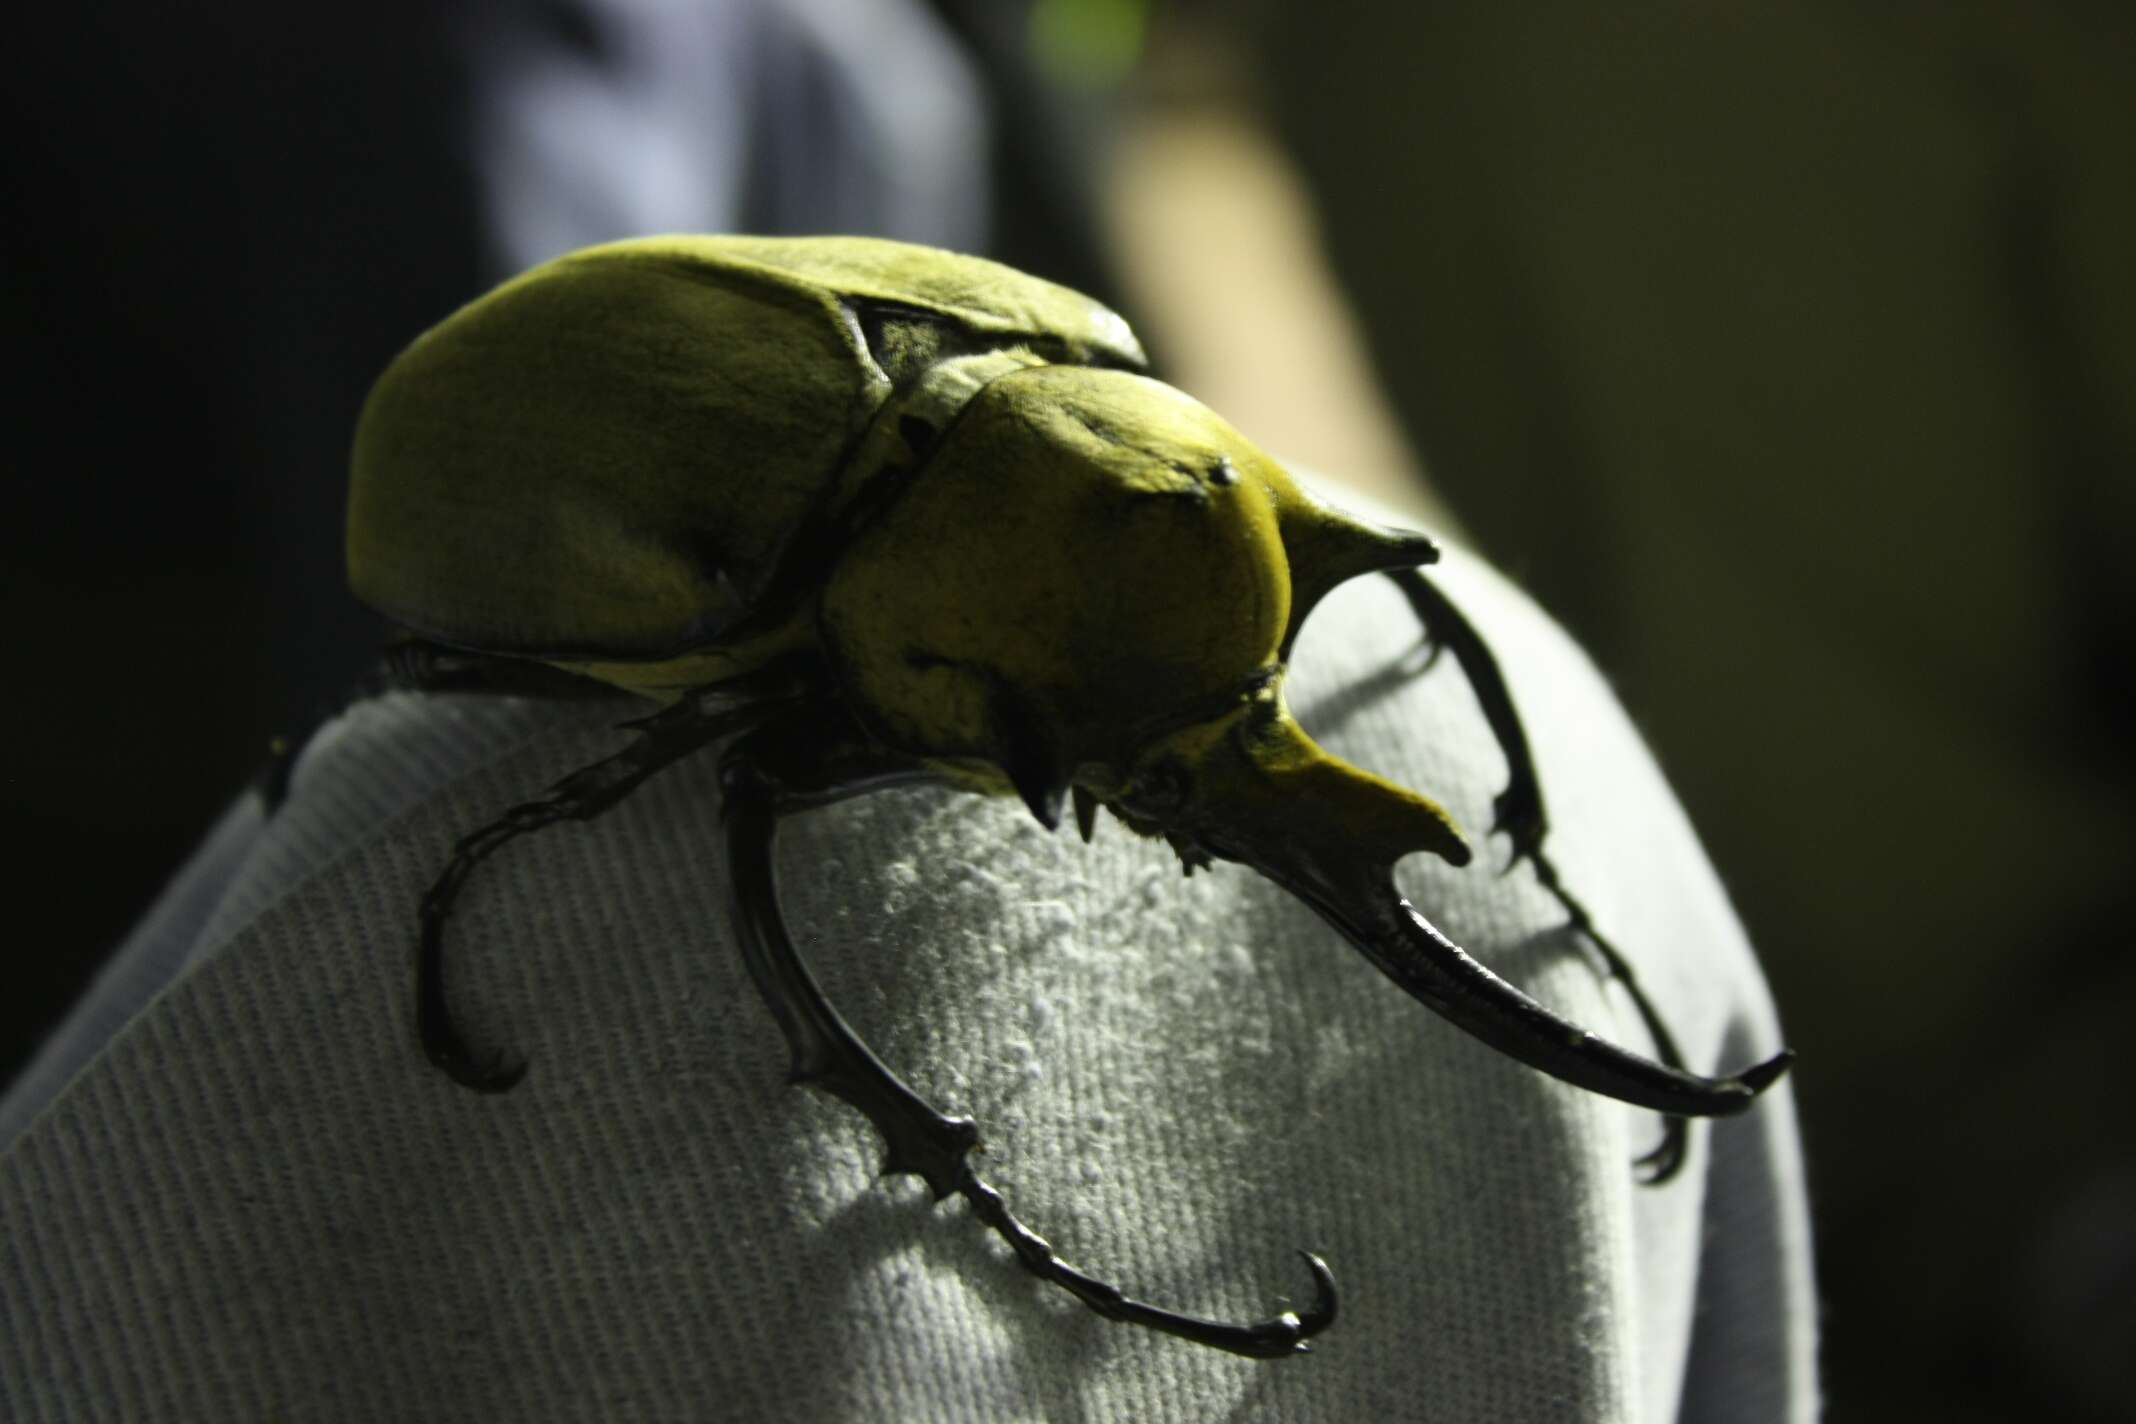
[0,0,2136,1422]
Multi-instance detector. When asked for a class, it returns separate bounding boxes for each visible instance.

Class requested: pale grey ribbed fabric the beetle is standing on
[0,555,1816,1422]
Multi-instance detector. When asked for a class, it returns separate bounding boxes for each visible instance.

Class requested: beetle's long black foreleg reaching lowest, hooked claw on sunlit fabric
[720,726,1335,1360]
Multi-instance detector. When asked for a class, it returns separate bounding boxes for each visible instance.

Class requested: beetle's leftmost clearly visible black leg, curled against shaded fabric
[417,673,795,1093]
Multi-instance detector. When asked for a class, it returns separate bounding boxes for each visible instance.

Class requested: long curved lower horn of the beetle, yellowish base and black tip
[1194,713,1790,1117]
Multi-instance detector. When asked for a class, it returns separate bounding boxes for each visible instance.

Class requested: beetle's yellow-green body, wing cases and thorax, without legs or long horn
[348,237,1467,836]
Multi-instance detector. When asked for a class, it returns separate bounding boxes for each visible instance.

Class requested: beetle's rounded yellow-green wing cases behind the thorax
[348,237,1143,685]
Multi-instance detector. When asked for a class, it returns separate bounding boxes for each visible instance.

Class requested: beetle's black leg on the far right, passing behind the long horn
[1388,568,1687,1187]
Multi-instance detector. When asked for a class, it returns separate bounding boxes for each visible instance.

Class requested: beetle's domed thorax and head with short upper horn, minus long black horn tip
[822,365,1467,869]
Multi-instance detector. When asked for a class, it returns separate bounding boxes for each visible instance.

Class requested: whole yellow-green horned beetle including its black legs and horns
[348,237,1788,1358]
